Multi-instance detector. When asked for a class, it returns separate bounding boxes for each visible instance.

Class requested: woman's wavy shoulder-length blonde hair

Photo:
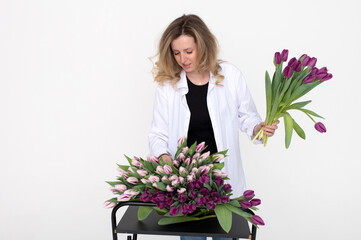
[153,14,224,86]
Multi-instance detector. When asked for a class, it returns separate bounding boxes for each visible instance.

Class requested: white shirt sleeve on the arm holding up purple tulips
[235,71,262,142]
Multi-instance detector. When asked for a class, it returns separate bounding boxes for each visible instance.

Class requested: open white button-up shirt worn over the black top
[149,63,262,197]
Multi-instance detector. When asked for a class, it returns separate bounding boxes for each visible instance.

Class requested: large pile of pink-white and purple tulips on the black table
[104,137,264,233]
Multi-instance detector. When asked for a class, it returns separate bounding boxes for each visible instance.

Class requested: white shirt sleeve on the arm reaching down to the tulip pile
[148,86,169,157]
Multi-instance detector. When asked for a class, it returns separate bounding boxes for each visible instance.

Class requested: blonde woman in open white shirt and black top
[149,15,278,239]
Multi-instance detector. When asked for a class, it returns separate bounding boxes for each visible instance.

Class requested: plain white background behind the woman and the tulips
[0,0,361,240]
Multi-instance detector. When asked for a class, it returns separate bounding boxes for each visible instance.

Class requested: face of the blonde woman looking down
[171,35,198,73]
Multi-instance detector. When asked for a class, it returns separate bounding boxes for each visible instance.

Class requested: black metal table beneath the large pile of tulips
[111,202,257,240]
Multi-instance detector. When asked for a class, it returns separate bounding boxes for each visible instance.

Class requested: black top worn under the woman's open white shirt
[186,77,218,154]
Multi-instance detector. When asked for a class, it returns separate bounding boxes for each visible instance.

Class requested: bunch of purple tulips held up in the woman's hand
[253,49,332,148]
